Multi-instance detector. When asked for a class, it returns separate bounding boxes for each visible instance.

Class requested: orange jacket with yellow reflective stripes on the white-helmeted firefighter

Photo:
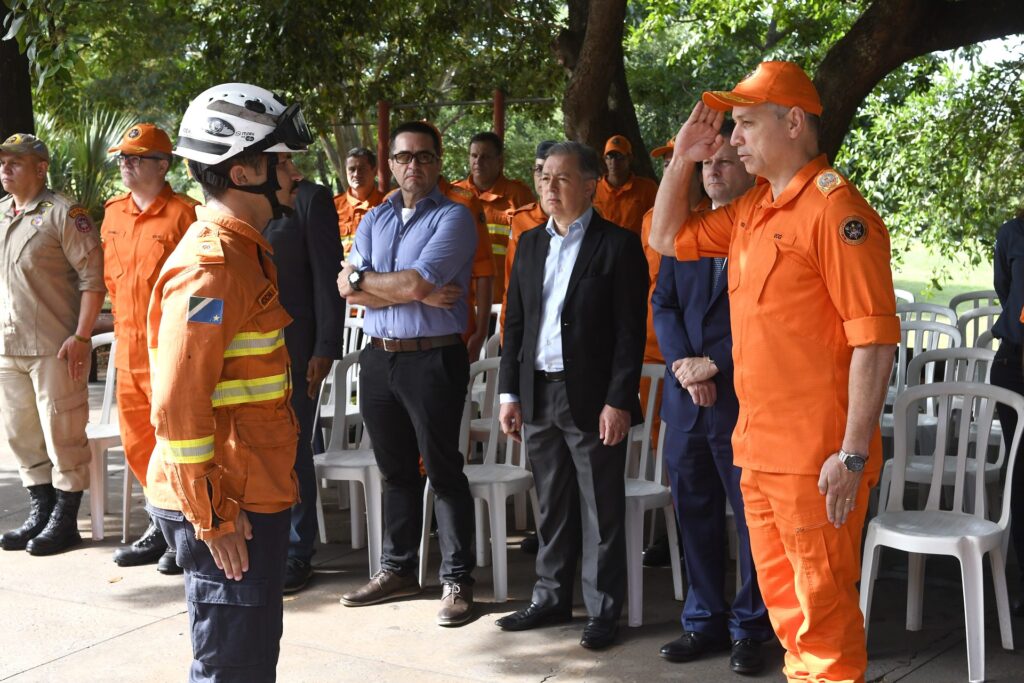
[147,207,298,540]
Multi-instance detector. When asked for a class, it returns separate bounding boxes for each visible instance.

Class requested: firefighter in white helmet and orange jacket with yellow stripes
[147,83,311,681]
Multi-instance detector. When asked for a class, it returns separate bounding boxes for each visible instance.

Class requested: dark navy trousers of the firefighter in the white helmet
[151,508,291,683]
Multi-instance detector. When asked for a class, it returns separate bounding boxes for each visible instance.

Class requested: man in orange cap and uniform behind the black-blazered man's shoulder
[594,135,657,234]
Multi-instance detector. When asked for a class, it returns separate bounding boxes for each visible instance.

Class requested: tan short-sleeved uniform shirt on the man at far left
[0,189,104,355]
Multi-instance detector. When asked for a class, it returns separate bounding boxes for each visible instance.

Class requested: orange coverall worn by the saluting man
[675,155,900,681]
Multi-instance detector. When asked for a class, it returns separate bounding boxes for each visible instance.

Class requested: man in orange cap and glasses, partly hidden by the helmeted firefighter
[101,123,197,573]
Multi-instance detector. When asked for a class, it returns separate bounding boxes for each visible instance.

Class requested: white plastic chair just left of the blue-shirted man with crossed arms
[313,351,384,577]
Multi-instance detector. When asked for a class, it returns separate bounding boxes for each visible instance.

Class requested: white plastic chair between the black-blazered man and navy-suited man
[625,362,683,627]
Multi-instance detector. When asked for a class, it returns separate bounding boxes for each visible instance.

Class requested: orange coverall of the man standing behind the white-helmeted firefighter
[100,184,198,489]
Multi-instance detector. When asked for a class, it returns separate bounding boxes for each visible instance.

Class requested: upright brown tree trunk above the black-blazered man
[555,0,655,177]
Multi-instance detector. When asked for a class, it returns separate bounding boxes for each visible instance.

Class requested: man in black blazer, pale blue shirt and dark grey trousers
[498,142,647,649]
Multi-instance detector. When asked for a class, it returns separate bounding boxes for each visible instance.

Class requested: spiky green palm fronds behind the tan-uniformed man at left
[36,109,135,222]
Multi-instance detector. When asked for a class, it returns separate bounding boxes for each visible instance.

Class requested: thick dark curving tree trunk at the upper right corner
[814,0,1024,159]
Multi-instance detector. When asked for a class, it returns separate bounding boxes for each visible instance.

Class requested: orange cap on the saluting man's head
[700,61,821,116]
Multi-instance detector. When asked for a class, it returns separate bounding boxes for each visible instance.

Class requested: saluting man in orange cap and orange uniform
[650,61,900,681]
